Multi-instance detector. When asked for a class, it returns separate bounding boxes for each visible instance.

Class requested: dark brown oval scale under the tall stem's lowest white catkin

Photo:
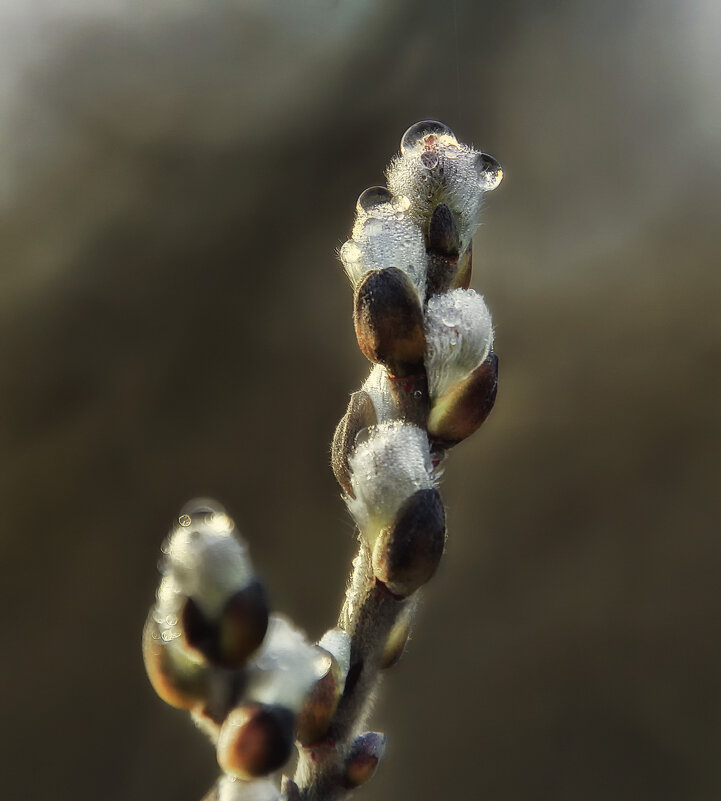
[373,489,446,597]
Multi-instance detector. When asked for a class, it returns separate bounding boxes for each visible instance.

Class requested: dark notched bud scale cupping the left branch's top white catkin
[182,579,268,669]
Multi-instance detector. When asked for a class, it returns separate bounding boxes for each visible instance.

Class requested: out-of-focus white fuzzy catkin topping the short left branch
[156,512,253,622]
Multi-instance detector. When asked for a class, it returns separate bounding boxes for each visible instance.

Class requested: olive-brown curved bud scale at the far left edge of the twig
[143,611,210,709]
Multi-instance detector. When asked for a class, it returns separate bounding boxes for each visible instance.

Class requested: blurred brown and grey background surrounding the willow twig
[0,0,721,801]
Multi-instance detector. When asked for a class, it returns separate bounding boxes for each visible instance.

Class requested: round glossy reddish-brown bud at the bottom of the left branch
[217,703,295,779]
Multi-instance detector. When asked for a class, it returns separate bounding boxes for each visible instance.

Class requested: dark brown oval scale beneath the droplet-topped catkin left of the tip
[353,267,426,376]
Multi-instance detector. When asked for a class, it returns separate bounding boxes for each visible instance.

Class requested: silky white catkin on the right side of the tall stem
[425,289,493,400]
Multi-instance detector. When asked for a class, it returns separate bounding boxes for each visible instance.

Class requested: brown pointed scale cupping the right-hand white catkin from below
[428,353,498,444]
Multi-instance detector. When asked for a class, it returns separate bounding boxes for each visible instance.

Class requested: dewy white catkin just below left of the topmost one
[340,197,426,301]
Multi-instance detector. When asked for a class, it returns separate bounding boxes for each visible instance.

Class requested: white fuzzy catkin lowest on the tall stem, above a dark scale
[345,421,434,545]
